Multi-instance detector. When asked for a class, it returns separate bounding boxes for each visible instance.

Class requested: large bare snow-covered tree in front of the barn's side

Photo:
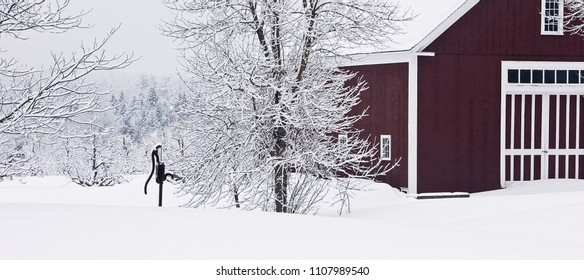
[164,0,408,213]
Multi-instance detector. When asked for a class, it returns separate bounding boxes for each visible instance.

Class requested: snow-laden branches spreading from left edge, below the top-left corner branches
[0,29,132,134]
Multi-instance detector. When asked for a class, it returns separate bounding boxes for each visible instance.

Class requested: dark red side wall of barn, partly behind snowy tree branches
[349,63,408,187]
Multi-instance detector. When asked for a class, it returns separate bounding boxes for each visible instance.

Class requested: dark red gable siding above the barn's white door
[426,0,584,57]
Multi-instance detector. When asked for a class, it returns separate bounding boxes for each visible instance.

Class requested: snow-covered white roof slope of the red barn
[340,0,479,66]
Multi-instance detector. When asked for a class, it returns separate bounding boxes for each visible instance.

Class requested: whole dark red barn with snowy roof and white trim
[344,0,584,196]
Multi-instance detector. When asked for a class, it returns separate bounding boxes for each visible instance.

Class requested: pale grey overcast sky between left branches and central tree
[0,0,178,75]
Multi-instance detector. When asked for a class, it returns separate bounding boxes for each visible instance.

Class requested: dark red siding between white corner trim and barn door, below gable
[418,55,501,193]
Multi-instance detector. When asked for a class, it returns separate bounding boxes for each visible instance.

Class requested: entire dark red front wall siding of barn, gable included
[416,0,584,193]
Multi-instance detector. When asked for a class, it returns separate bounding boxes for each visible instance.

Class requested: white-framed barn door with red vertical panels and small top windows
[501,61,584,187]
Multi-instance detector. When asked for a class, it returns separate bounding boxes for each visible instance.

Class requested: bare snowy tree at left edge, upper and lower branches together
[0,0,133,178]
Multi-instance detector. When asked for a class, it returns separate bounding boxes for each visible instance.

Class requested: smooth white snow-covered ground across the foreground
[0,176,584,260]
